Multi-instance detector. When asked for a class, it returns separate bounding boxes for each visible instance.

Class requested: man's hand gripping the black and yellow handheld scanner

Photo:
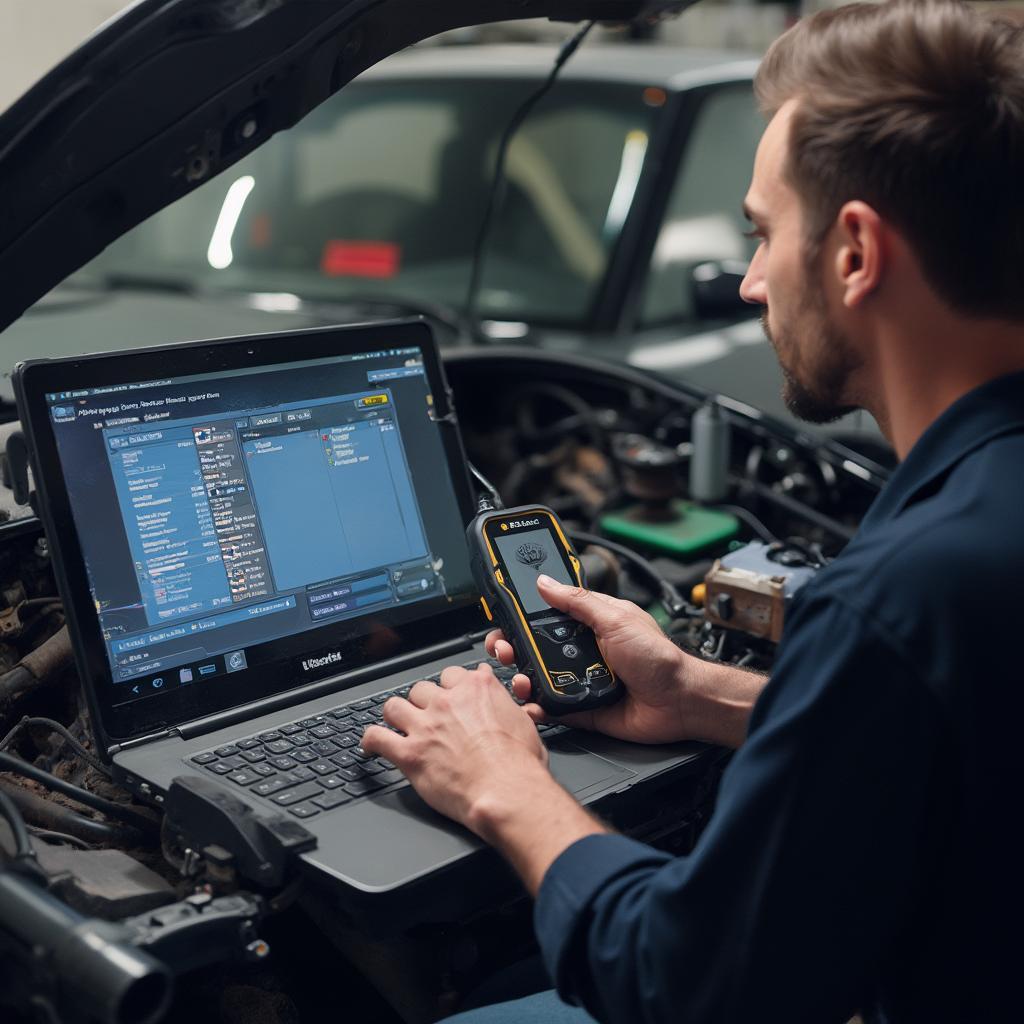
[485,575,765,746]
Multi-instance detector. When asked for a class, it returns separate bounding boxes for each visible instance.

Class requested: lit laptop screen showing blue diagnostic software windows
[33,325,475,729]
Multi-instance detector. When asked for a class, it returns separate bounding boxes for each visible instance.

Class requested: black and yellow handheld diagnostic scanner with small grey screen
[466,505,624,715]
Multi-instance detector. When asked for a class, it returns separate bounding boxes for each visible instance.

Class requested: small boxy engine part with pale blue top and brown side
[703,543,817,643]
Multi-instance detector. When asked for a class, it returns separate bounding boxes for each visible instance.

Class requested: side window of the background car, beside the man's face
[641,84,765,325]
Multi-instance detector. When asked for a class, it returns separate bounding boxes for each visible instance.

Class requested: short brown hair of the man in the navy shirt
[756,0,1024,321]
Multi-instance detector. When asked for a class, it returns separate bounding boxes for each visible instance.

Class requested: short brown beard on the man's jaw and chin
[761,276,861,423]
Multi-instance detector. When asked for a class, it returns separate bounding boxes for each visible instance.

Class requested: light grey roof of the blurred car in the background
[360,43,758,91]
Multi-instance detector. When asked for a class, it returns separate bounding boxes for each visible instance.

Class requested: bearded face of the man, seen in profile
[739,100,861,423]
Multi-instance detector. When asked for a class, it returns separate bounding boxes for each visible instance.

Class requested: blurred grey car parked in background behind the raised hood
[5,37,884,457]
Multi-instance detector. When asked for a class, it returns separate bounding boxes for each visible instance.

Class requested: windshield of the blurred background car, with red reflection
[77,77,664,326]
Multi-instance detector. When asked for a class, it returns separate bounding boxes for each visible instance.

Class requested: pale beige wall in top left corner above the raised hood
[0,0,129,110]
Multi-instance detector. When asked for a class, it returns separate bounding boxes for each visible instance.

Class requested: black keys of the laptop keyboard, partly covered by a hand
[189,658,564,818]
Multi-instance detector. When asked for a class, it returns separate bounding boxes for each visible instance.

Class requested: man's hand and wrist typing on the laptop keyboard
[362,665,605,893]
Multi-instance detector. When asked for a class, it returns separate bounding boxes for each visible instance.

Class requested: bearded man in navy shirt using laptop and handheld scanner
[364,0,1024,1024]
